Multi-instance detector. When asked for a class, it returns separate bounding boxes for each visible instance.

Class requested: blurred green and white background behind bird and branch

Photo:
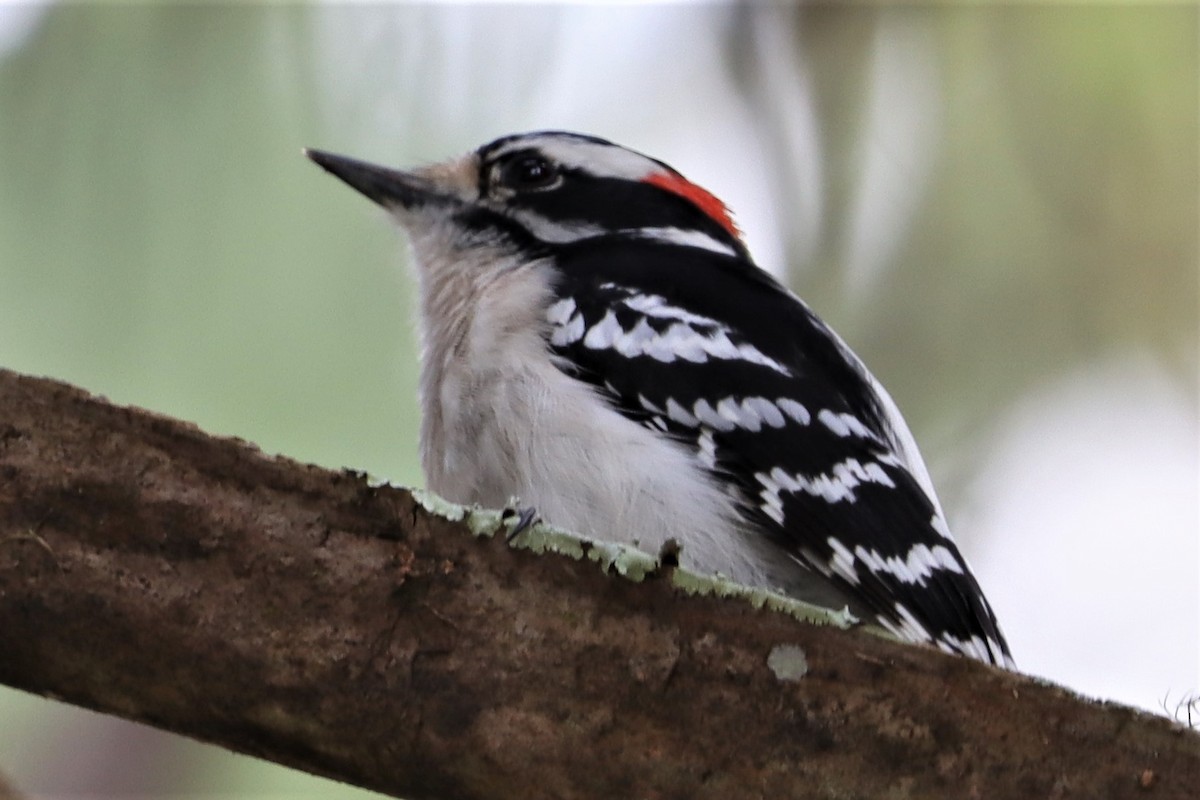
[0,4,1200,796]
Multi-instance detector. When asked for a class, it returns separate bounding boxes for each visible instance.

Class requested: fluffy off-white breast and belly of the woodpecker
[403,221,864,608]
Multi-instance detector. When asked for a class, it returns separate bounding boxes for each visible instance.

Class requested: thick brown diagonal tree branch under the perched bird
[0,371,1200,800]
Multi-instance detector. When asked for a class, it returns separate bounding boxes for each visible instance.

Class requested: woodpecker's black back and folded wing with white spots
[547,239,1013,666]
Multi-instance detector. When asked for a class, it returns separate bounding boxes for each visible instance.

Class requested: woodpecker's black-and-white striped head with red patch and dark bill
[305,132,745,262]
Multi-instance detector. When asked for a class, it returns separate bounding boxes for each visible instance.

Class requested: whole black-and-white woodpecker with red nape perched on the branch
[306,132,1013,667]
